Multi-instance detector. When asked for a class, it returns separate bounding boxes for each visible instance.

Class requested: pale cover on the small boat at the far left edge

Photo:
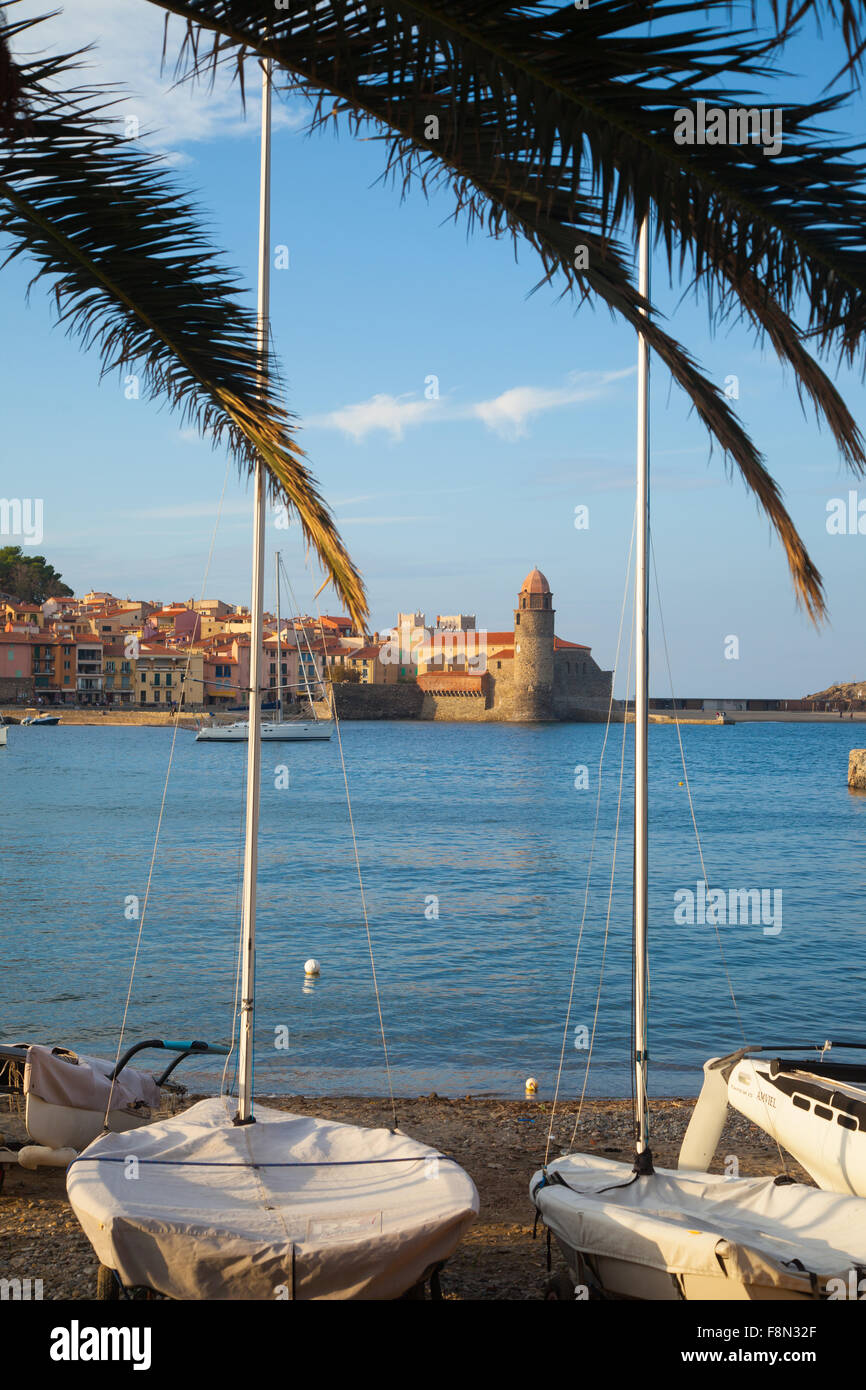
[24,1044,161,1111]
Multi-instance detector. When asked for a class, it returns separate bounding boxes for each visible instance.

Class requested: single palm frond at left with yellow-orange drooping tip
[0,13,367,626]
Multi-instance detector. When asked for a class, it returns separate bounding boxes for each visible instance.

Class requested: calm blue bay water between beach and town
[0,723,866,1095]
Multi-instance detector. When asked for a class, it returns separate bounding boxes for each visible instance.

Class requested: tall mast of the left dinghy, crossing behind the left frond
[235,58,271,1125]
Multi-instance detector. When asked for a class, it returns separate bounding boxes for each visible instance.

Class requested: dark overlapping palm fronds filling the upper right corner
[152,0,866,616]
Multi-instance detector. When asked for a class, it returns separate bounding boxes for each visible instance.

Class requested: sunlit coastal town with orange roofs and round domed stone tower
[0,569,613,721]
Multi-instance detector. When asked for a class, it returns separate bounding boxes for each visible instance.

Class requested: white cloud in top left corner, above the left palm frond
[14,0,307,154]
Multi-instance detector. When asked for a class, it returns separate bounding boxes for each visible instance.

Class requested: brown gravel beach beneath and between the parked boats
[0,1094,809,1300]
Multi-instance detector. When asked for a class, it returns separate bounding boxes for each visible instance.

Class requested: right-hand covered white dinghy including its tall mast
[530,220,866,1300]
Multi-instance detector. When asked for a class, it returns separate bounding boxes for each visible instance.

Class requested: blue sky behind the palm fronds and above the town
[0,0,866,696]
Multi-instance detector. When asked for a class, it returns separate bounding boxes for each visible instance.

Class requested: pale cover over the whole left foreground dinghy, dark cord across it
[67,1097,478,1300]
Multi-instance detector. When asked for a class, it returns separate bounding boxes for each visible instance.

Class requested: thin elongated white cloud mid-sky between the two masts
[304,367,634,443]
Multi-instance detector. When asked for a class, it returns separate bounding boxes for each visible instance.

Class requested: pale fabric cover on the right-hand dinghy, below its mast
[530,1154,866,1294]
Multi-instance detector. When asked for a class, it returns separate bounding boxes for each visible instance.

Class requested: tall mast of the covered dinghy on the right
[634,215,652,1162]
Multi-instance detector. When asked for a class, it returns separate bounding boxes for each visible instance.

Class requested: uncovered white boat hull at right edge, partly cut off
[680,1041,866,1197]
